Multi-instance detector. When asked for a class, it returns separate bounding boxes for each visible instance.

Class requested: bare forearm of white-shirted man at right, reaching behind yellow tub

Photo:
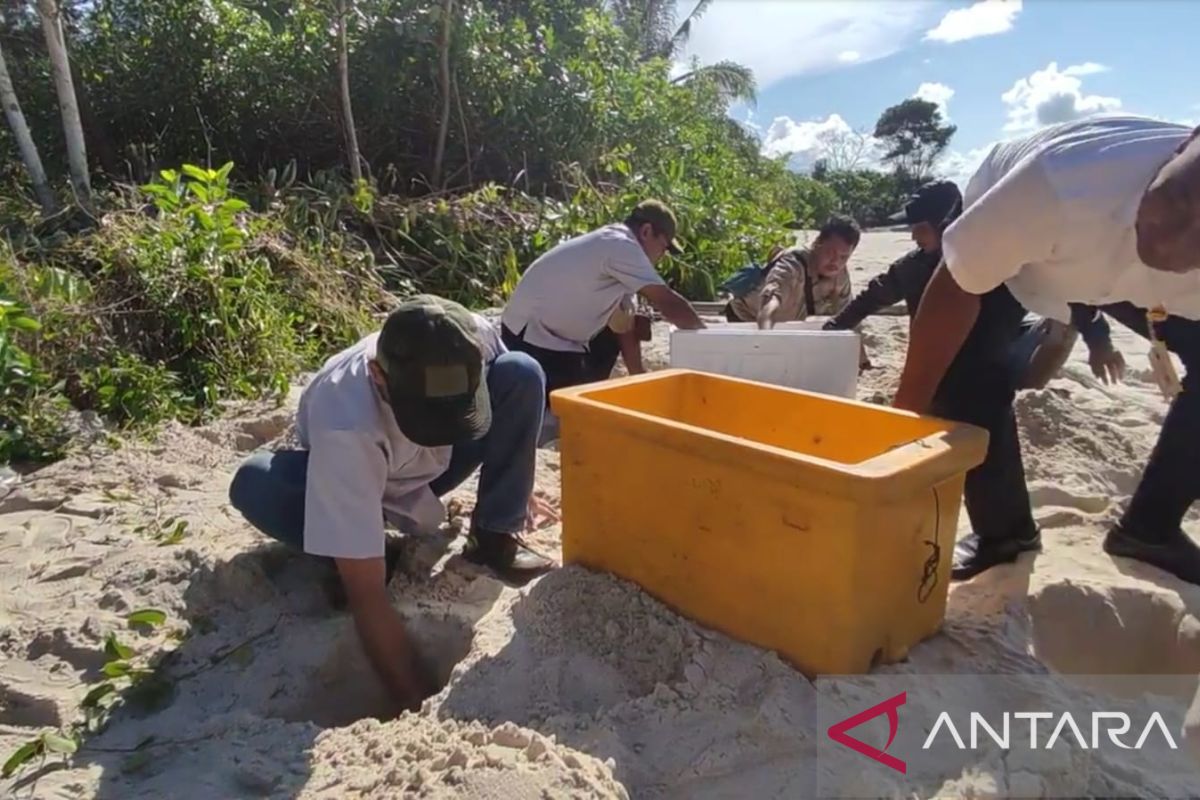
[893,263,979,414]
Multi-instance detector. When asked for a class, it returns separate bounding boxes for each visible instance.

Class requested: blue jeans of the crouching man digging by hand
[229,353,546,549]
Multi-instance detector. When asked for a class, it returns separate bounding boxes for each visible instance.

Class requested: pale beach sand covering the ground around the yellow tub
[0,227,1200,799]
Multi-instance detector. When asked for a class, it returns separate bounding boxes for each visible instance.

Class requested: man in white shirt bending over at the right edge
[894,116,1200,583]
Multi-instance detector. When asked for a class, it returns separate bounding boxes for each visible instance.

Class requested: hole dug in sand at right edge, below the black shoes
[1030,582,1200,703]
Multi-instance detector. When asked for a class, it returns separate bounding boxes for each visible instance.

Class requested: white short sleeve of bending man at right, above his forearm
[942,158,1062,294]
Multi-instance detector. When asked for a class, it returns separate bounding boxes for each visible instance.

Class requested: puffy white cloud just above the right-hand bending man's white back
[1001,61,1121,133]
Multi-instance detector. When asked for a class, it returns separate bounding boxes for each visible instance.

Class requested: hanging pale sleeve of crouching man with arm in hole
[304,431,388,559]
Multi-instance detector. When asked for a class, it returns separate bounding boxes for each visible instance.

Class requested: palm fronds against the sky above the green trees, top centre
[612,0,757,102]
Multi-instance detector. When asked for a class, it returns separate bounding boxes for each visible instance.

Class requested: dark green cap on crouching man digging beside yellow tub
[376,295,492,447]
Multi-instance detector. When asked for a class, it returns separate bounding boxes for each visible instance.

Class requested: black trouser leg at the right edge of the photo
[1100,302,1200,540]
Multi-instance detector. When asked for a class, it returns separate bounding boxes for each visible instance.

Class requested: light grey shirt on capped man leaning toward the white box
[502,224,662,353]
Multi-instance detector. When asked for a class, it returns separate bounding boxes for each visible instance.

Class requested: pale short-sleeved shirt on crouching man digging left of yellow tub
[296,314,505,559]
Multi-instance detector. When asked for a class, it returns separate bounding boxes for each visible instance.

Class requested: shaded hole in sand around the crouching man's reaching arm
[278,612,473,728]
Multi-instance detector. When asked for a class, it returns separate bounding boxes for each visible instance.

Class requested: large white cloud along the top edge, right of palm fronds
[677,0,938,89]
